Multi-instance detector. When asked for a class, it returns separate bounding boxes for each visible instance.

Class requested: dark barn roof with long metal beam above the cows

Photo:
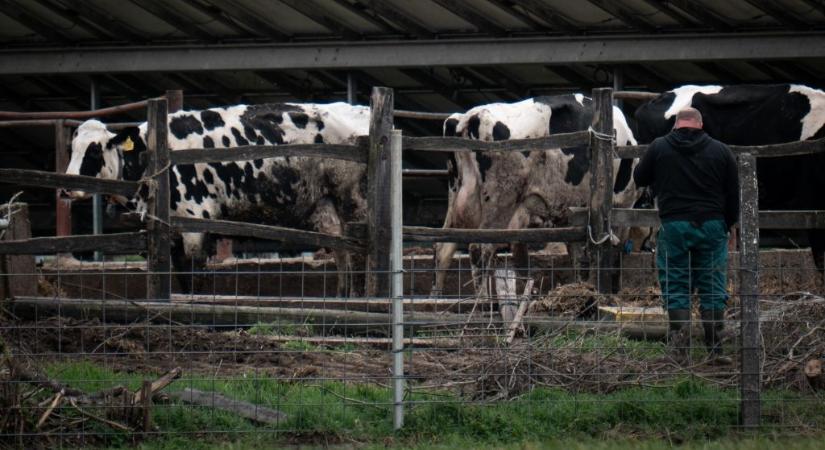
[0,0,825,236]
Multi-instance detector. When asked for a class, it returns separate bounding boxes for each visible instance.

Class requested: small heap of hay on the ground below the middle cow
[530,283,613,319]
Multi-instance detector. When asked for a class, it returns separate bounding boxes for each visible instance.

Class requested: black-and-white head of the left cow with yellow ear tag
[66,120,146,203]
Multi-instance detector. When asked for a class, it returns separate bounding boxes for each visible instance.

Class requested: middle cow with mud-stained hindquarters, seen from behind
[432,94,638,295]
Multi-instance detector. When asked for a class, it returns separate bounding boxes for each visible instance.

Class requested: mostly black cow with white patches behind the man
[635,84,825,269]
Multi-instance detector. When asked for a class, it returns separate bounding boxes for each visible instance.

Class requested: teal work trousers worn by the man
[656,220,728,310]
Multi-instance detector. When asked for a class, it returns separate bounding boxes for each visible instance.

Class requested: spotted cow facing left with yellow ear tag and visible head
[66,103,370,295]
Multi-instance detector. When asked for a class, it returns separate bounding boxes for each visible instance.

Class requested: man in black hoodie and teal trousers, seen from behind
[633,107,739,364]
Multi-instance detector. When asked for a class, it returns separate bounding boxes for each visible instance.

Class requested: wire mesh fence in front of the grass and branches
[0,248,825,447]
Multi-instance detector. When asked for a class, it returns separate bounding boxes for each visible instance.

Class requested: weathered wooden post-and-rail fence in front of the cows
[0,87,825,426]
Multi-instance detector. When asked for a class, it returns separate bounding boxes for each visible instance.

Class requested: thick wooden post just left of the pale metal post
[366,87,394,296]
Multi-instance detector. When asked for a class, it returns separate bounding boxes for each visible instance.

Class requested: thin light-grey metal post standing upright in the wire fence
[390,130,404,430]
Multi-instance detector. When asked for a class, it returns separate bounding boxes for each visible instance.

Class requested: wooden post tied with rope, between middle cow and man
[587,88,615,294]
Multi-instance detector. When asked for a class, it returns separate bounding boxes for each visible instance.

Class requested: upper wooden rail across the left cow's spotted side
[170,144,367,164]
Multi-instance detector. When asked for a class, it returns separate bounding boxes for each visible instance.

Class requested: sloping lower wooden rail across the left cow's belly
[171,216,365,251]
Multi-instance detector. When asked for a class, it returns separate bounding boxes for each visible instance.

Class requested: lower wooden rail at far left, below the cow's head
[0,231,146,255]
